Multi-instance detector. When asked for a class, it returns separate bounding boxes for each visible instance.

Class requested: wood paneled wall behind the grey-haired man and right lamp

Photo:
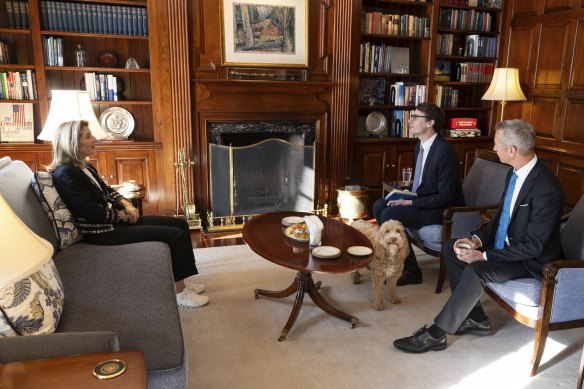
[500,0,584,205]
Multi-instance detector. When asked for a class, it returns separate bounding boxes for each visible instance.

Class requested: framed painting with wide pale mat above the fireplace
[221,0,308,67]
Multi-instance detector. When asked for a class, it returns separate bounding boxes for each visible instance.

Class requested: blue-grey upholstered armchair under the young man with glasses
[408,149,511,293]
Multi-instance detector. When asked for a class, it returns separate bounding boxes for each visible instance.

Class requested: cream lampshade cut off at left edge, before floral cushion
[0,195,53,288]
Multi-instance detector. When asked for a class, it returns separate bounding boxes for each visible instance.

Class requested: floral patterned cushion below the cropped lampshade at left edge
[0,259,64,338]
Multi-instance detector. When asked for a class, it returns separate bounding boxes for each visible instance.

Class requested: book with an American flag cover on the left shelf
[0,103,34,143]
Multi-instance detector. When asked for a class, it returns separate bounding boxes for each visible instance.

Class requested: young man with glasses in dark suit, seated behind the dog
[373,103,464,285]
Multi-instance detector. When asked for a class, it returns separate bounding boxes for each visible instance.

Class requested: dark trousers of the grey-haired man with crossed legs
[434,239,532,334]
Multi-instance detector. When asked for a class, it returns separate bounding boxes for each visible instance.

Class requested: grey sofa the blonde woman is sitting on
[0,157,186,388]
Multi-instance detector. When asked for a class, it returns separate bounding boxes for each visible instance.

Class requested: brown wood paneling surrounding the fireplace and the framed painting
[188,0,358,211]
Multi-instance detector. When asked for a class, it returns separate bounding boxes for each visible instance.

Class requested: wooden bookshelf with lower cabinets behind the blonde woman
[0,0,164,213]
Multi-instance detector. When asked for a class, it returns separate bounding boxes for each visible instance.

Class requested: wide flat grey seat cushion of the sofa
[55,242,184,371]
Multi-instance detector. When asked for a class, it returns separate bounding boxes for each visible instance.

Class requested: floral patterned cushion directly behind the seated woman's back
[31,172,82,249]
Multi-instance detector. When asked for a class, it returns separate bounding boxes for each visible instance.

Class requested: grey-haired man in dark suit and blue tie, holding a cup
[393,119,564,353]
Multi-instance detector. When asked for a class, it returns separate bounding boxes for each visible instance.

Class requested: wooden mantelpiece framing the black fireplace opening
[192,80,331,217]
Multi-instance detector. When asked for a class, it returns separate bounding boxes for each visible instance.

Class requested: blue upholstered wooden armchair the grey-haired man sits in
[485,196,584,376]
